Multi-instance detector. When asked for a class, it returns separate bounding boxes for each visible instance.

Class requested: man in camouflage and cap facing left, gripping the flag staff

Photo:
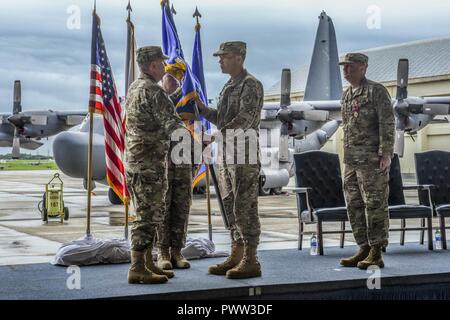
[197,41,264,278]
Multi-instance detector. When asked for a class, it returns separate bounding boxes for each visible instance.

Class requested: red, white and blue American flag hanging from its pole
[89,12,129,203]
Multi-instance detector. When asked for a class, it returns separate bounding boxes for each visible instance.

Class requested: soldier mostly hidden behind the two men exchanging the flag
[157,73,192,270]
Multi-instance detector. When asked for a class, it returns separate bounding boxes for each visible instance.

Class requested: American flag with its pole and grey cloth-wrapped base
[52,4,130,265]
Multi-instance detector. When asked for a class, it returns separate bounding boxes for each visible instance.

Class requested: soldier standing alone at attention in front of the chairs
[339,53,395,269]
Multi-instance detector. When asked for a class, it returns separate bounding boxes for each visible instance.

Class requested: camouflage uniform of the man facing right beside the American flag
[126,69,184,251]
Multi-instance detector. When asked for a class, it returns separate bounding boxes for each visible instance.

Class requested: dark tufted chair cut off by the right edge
[414,150,450,249]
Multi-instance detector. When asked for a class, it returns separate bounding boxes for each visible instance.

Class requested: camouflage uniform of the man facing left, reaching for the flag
[202,65,264,246]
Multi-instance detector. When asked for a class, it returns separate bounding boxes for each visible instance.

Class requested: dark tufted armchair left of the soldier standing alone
[294,151,351,255]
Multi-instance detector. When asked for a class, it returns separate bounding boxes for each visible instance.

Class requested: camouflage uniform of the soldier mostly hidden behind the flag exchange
[157,88,192,249]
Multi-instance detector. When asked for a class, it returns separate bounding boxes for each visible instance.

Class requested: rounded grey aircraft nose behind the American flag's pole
[53,131,106,181]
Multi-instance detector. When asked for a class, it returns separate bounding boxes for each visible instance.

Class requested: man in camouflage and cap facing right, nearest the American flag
[125,46,184,283]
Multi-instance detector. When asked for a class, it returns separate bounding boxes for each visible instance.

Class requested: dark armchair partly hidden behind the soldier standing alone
[388,154,433,250]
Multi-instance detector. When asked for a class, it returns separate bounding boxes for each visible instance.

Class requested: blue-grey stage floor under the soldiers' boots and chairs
[0,243,450,300]
